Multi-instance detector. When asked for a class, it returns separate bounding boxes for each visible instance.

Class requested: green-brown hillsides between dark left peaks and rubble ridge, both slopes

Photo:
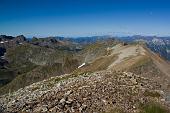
[0,44,79,94]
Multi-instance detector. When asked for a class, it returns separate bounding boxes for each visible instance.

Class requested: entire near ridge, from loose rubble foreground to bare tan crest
[0,43,170,113]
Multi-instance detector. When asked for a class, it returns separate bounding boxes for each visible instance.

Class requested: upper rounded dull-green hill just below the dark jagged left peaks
[6,44,64,68]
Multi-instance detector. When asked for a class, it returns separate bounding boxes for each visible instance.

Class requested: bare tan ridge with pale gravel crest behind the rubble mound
[74,44,170,101]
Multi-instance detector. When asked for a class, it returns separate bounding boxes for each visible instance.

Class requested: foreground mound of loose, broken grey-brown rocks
[0,71,167,113]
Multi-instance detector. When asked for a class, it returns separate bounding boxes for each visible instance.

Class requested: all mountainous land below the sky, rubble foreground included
[0,35,170,113]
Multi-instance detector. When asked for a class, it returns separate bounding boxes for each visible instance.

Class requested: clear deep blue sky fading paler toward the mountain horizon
[0,0,170,36]
